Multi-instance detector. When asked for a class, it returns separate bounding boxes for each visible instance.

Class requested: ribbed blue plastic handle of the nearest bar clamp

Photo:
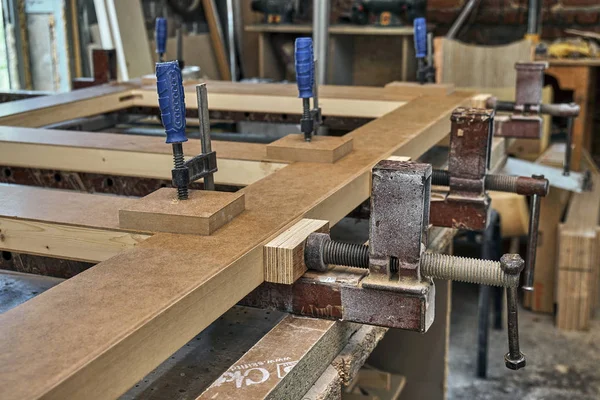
[156,61,187,143]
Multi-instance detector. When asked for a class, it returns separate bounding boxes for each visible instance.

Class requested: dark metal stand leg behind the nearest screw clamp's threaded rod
[477,210,502,378]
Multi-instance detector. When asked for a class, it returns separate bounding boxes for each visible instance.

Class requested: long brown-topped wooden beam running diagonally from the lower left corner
[0,92,470,399]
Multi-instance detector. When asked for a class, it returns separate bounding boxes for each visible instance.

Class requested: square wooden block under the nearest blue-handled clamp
[119,188,245,236]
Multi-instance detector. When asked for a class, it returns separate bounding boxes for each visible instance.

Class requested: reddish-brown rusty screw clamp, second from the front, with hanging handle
[430,108,549,291]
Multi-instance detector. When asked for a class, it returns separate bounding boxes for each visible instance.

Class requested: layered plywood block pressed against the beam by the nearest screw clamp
[263,218,329,285]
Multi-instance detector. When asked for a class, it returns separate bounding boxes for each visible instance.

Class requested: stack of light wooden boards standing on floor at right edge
[556,152,600,330]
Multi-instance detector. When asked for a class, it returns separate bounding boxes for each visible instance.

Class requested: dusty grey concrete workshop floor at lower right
[448,283,600,400]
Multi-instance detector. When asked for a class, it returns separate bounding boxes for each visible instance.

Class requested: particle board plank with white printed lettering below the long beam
[198,316,360,400]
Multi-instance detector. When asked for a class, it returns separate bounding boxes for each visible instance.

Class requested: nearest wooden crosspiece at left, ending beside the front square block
[0,184,149,262]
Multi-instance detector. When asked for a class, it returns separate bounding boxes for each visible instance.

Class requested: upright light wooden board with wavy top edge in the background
[435,38,533,88]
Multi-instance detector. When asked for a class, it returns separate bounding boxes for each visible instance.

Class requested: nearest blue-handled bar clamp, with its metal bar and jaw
[156,61,217,200]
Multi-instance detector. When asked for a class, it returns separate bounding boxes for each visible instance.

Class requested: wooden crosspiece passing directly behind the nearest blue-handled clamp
[0,127,287,186]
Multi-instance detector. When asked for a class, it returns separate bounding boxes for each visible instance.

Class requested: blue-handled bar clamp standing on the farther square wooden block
[294,37,322,142]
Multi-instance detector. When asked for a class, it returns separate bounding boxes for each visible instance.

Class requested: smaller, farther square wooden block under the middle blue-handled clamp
[267,134,352,164]
